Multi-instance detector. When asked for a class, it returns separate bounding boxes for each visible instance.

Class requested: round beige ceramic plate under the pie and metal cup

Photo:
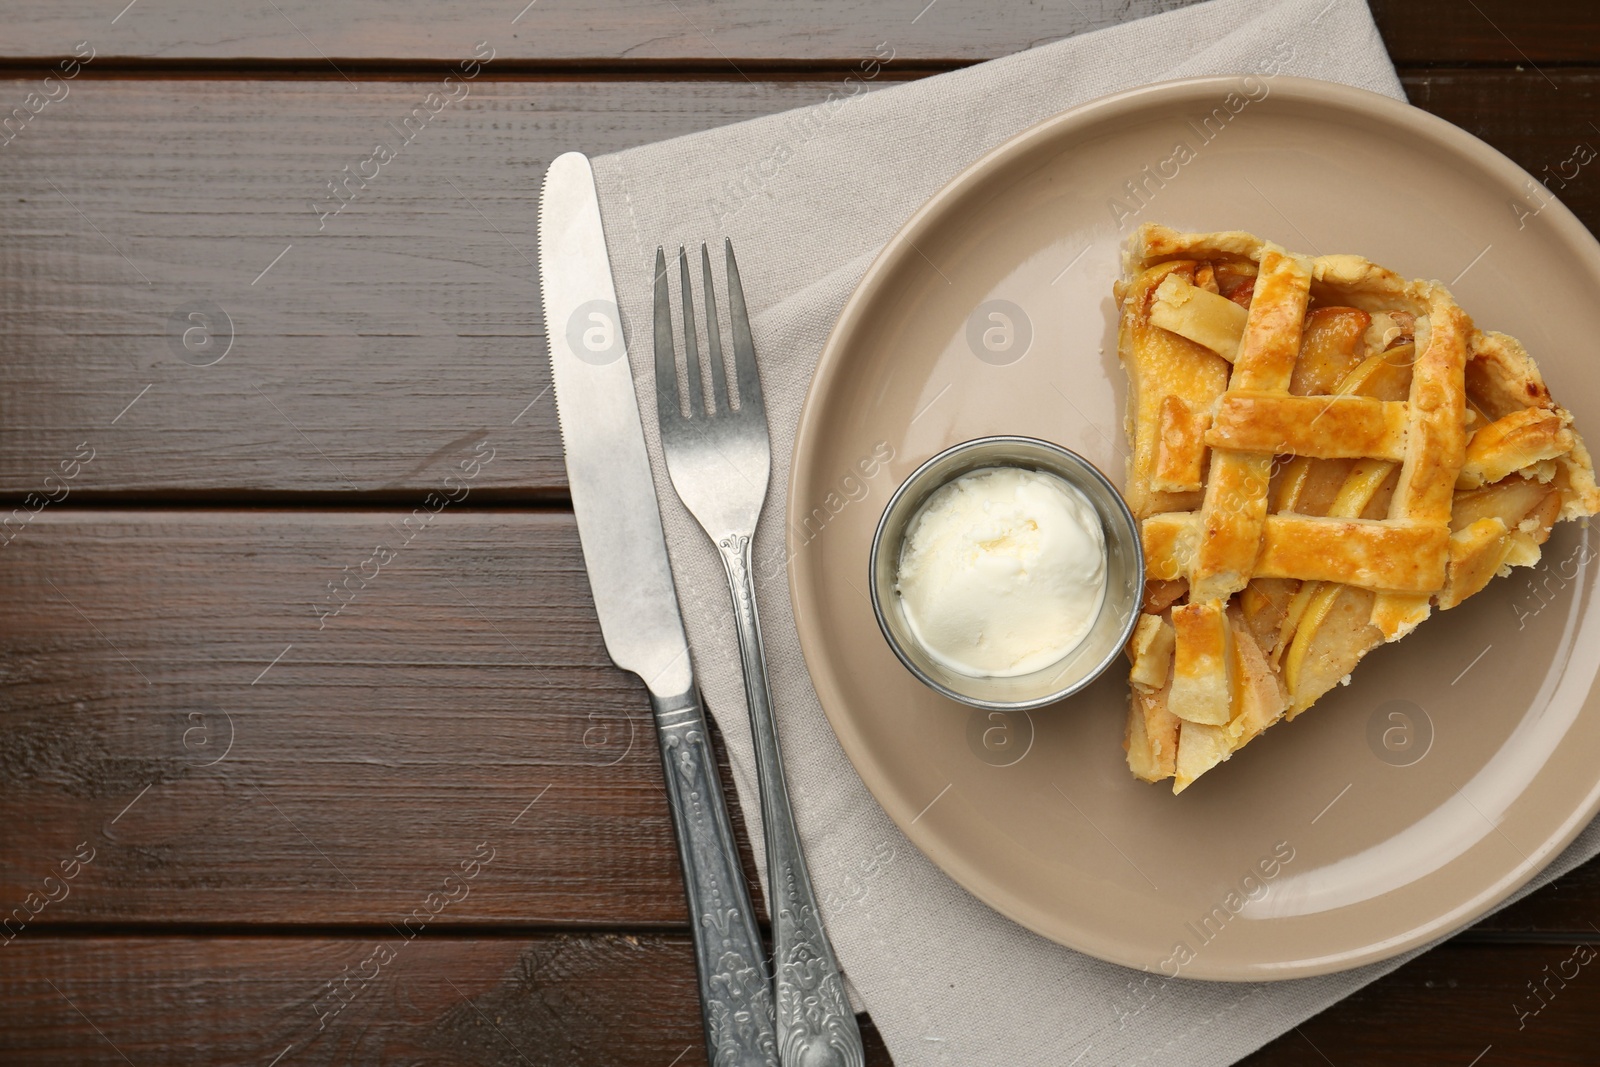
[789,77,1600,979]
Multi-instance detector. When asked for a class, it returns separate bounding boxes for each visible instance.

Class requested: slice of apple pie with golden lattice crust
[1115,226,1600,793]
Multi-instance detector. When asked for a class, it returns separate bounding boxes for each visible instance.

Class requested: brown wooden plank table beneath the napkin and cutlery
[0,0,1600,1067]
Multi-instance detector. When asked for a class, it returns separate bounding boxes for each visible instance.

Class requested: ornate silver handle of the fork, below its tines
[717,534,866,1067]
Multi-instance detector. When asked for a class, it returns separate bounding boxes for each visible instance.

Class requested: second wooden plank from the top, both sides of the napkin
[9,70,1600,504]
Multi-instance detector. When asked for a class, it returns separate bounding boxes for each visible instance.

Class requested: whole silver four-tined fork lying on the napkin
[656,242,864,1067]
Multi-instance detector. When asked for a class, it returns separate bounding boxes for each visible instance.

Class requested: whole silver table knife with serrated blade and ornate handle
[539,152,778,1067]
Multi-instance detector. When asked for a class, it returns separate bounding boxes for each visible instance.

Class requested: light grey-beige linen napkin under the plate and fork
[594,0,1600,1067]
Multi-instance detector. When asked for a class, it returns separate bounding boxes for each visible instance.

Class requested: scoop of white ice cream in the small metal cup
[896,467,1106,677]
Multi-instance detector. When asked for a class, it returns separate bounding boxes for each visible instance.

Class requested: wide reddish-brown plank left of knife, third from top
[0,508,768,933]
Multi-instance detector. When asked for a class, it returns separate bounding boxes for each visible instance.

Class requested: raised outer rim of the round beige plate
[784,74,1600,982]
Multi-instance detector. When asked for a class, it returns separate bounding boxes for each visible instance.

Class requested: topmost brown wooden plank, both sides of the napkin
[0,0,1600,72]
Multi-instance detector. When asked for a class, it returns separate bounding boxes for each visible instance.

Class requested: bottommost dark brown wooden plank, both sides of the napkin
[9,934,1600,1067]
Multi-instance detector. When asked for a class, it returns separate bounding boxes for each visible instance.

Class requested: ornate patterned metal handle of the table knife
[650,689,778,1067]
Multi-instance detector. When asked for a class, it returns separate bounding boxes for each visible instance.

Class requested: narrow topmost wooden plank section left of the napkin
[0,0,1195,70]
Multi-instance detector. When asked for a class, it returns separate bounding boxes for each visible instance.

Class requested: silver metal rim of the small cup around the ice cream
[867,434,1144,712]
